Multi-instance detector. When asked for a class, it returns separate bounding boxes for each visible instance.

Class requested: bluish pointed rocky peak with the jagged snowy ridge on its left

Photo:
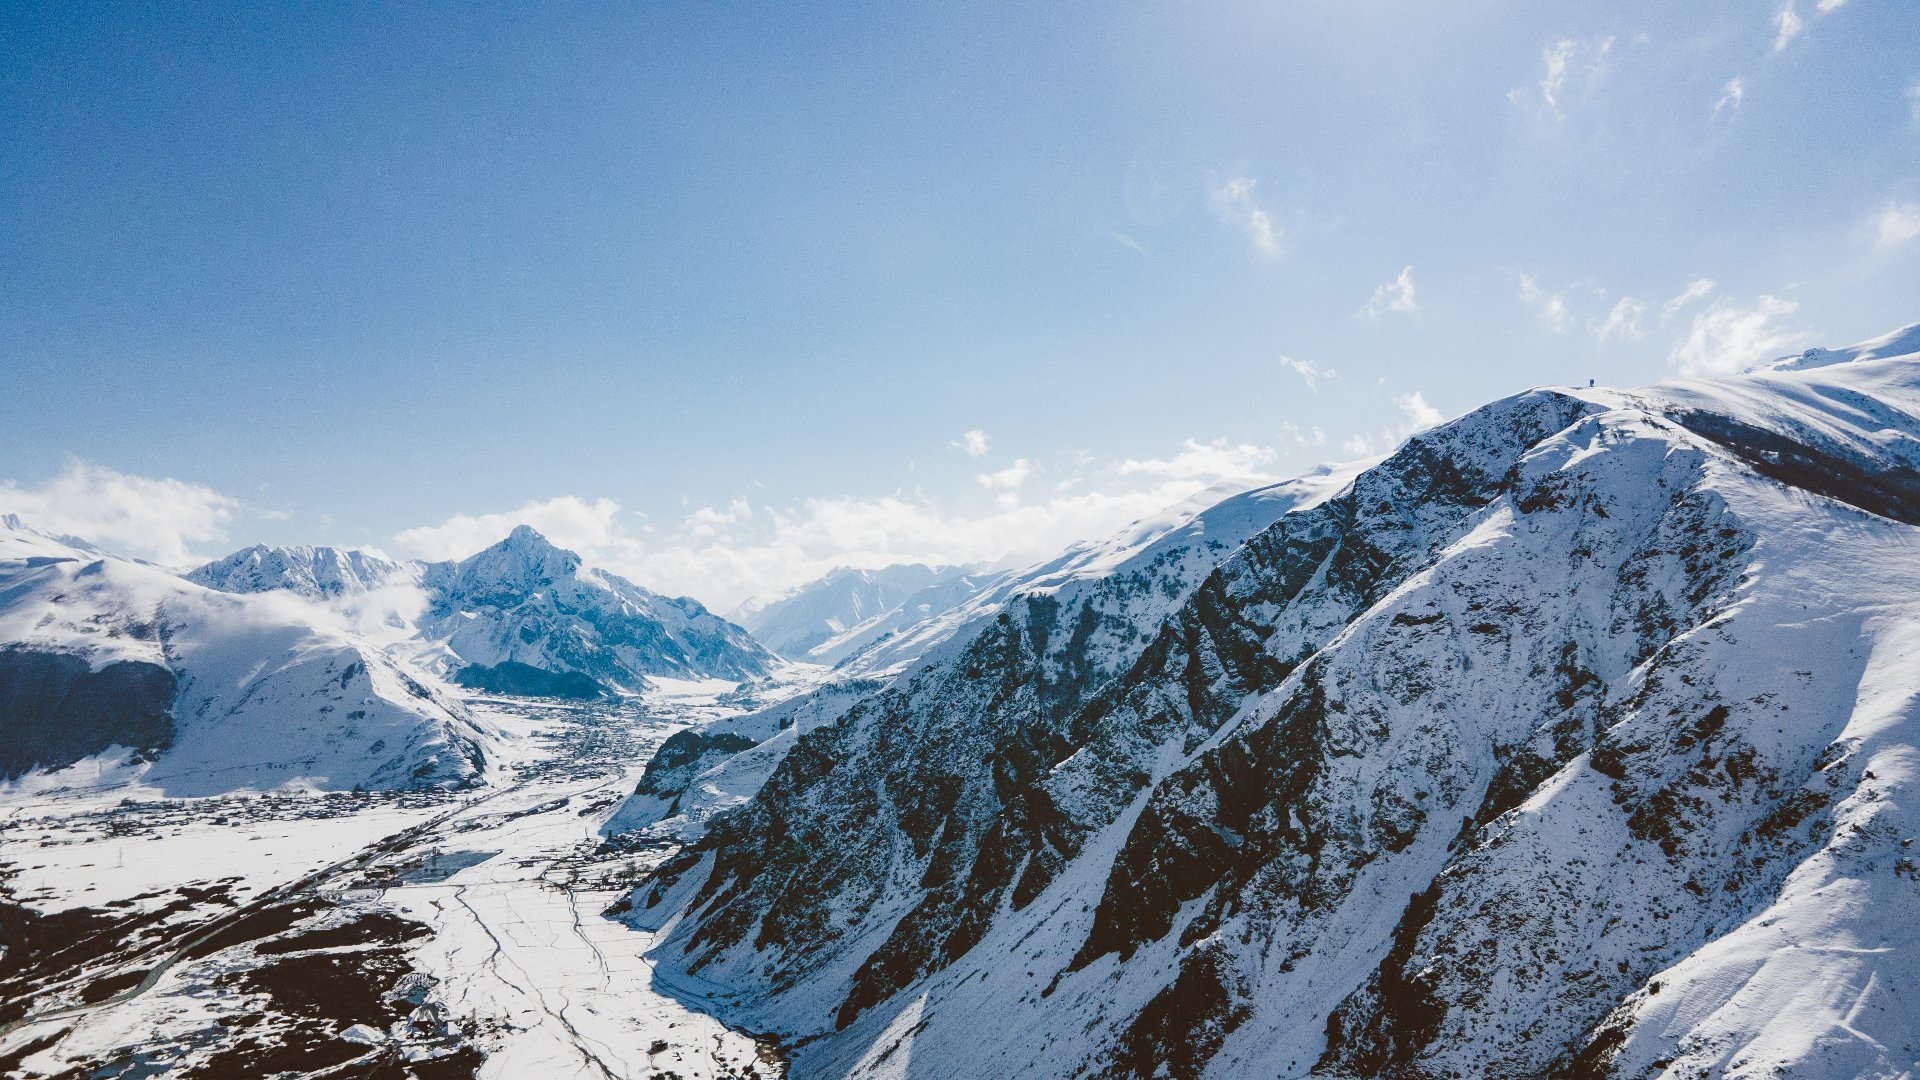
[188,525,778,698]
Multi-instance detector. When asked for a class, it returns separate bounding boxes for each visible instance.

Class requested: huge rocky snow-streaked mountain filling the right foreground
[630,329,1920,1076]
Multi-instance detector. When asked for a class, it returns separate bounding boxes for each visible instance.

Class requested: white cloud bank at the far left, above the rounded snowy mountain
[0,461,240,565]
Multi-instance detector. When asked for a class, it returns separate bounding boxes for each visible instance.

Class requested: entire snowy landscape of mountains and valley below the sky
[11,327,1920,1080]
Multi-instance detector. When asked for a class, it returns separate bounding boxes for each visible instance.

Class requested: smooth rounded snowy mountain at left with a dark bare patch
[0,519,484,796]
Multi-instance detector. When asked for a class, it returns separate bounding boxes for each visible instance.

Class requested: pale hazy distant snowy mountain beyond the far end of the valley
[733,563,983,665]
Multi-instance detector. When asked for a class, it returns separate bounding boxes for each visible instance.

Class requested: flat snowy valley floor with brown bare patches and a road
[0,684,781,1080]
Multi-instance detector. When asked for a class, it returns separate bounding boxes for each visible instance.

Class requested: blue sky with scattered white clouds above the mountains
[0,0,1920,605]
